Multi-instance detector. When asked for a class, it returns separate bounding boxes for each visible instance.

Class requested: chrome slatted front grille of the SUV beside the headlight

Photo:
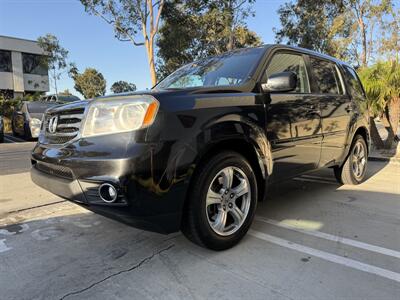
[43,108,85,144]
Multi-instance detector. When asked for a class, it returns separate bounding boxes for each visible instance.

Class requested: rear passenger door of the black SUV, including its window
[310,56,351,167]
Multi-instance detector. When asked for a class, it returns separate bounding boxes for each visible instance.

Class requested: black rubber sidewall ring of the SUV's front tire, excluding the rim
[192,152,258,250]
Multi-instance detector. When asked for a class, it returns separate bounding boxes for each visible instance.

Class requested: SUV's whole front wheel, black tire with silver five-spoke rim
[182,151,258,250]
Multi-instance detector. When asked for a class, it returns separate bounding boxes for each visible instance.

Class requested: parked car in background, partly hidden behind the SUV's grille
[11,101,59,140]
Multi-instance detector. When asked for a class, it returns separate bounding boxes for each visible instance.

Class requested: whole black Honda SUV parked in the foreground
[31,45,370,250]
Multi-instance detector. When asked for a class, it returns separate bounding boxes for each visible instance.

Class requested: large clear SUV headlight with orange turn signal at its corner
[82,95,159,137]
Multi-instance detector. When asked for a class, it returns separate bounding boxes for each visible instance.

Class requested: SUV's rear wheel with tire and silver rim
[333,135,368,185]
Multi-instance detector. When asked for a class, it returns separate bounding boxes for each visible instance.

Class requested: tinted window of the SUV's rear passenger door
[310,57,343,95]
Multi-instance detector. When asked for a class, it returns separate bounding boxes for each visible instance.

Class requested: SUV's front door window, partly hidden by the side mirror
[265,53,310,93]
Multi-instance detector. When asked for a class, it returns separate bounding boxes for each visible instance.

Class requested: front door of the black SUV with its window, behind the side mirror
[263,50,322,181]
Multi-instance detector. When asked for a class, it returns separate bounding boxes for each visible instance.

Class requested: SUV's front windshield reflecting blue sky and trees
[156,48,265,89]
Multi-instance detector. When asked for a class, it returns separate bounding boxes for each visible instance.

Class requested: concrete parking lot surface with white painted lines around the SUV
[0,143,400,299]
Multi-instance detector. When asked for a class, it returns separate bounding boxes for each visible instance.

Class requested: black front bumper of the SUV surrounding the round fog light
[31,139,193,233]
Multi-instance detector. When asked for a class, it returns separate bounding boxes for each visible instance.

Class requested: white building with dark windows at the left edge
[0,35,49,98]
